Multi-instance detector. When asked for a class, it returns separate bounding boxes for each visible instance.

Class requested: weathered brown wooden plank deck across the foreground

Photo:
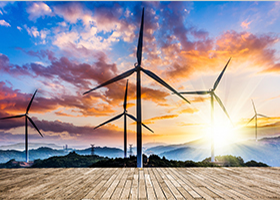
[0,167,280,200]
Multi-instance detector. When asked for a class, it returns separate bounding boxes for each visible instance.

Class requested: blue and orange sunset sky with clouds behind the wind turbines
[0,1,280,148]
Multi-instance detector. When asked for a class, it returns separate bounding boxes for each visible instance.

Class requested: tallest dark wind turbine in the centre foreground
[84,8,190,168]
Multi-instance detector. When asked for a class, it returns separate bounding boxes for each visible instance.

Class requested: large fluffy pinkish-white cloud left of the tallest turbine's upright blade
[53,2,136,57]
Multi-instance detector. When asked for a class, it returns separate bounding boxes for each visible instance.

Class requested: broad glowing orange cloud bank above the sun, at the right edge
[163,31,280,81]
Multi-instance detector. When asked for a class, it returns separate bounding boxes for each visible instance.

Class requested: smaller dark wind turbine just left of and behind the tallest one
[94,80,154,158]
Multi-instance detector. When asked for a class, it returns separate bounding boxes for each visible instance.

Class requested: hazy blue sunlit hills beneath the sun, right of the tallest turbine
[145,136,280,166]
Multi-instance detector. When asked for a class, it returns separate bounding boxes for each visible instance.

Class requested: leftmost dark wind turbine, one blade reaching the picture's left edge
[0,90,43,162]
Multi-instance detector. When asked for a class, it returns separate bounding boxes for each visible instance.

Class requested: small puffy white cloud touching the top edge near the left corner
[27,2,52,21]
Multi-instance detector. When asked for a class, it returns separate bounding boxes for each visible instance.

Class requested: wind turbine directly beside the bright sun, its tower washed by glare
[180,58,231,162]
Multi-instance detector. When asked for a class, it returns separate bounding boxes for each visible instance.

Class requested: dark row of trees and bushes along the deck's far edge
[0,151,268,168]
